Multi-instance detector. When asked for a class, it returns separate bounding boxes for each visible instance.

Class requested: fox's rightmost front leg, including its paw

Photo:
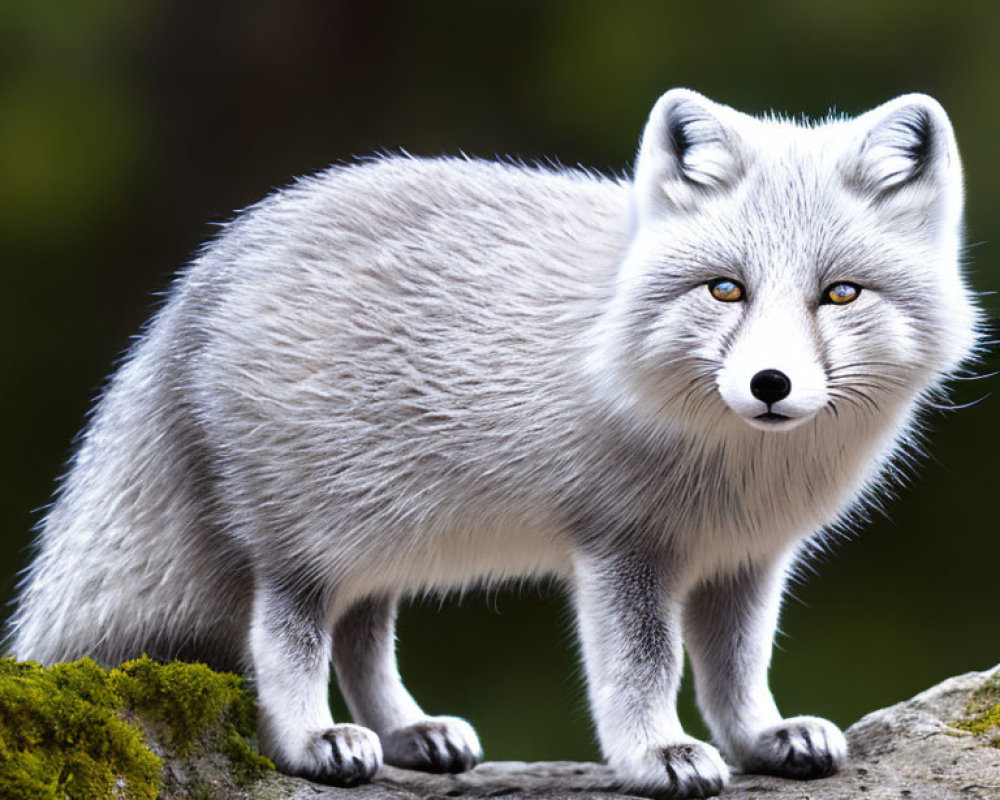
[684,562,847,779]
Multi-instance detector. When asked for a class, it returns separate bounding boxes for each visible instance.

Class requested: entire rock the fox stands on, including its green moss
[0,659,1000,800]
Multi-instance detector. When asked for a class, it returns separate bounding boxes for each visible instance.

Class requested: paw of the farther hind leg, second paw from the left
[382,717,483,772]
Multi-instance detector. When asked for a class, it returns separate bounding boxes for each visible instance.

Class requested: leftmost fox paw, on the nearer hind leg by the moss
[290,724,382,786]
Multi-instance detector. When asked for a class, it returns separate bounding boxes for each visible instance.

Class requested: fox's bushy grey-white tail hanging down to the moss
[8,310,251,668]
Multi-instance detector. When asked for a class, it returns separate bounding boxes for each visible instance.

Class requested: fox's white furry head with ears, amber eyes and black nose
[599,89,978,432]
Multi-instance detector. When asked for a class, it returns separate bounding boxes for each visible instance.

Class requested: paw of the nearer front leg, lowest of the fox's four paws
[618,739,729,800]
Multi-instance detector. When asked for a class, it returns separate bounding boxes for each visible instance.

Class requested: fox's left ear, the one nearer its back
[635,89,743,212]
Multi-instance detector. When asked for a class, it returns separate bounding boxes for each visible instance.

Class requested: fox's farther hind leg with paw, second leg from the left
[333,595,482,772]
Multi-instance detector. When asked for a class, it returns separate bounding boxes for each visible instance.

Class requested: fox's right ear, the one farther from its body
[850,94,961,198]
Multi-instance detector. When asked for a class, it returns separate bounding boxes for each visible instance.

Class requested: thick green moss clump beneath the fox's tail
[0,657,273,800]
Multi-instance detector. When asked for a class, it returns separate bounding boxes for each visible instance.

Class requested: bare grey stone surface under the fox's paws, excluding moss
[174,666,1000,800]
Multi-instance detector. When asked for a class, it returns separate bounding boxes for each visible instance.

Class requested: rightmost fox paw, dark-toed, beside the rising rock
[740,717,847,780]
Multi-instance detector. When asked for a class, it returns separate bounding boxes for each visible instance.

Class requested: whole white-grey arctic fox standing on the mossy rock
[11,89,979,797]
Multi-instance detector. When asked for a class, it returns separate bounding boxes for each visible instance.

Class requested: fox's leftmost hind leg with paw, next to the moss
[250,580,382,786]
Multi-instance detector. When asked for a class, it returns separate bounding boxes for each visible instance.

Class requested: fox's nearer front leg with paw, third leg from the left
[574,553,729,799]
